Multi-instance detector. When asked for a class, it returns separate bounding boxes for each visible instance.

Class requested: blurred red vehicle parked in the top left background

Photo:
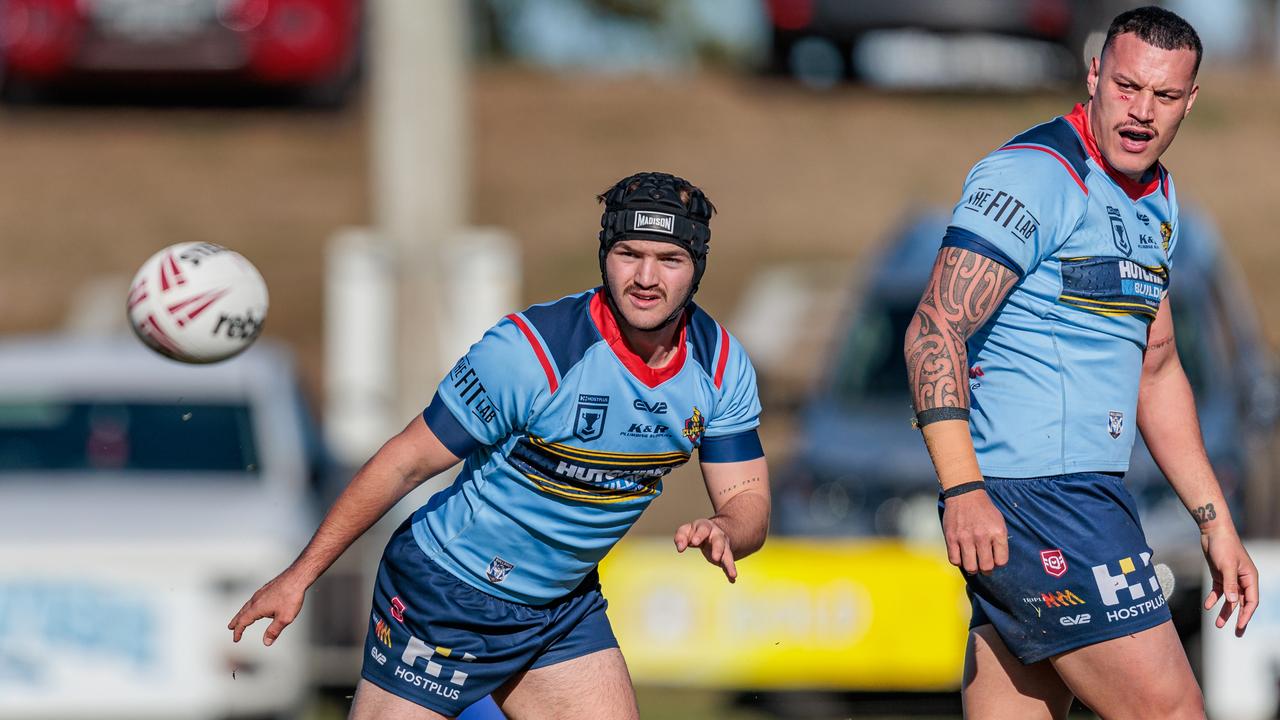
[0,0,362,102]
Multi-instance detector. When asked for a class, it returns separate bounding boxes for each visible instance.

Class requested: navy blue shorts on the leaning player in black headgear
[361,521,618,716]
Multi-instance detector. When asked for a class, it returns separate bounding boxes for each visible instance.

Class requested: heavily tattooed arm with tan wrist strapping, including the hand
[902,247,1018,573]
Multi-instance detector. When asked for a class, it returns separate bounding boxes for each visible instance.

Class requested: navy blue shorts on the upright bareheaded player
[965,473,1170,665]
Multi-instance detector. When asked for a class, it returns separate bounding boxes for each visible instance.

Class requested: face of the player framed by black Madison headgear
[604,240,694,331]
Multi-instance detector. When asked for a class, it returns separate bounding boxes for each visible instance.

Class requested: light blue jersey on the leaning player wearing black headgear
[412,290,763,605]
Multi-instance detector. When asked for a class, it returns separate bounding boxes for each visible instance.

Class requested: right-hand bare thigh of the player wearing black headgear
[493,647,640,720]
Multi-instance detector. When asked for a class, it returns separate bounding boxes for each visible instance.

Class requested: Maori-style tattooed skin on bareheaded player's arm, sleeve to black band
[904,247,1018,413]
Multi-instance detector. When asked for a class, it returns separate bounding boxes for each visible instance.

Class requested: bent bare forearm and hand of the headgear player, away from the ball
[676,457,771,583]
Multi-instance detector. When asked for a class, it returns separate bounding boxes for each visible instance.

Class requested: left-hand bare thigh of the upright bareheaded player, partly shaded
[963,625,1071,720]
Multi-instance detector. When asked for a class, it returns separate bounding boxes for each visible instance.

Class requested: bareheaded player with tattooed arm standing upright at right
[905,6,1258,720]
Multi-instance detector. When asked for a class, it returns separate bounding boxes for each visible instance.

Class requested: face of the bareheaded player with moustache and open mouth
[1088,33,1199,179]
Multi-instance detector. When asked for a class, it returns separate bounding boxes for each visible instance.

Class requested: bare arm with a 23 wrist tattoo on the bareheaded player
[1138,299,1258,634]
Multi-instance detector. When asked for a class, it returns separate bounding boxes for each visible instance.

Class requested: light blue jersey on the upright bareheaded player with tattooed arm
[942,105,1178,478]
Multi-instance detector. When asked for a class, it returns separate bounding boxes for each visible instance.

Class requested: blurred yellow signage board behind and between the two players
[600,538,969,691]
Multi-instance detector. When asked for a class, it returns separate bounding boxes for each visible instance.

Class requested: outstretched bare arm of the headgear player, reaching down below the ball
[227,416,458,644]
